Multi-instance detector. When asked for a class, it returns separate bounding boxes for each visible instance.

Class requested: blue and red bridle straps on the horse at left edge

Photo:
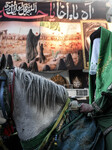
[0,69,14,120]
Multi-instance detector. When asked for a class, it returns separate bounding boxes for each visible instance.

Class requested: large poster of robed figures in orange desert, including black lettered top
[0,0,108,72]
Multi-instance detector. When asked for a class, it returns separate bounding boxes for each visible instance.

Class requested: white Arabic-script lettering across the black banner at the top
[4,1,95,20]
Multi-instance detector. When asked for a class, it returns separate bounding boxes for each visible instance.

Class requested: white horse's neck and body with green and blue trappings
[0,54,104,150]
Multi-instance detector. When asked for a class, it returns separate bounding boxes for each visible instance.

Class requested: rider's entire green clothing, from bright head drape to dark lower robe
[89,27,112,150]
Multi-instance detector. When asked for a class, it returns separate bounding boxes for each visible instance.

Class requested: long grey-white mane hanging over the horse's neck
[15,68,68,110]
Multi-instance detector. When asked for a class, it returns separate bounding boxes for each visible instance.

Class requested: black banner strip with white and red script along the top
[0,1,107,22]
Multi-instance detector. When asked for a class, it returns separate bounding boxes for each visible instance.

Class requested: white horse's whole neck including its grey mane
[0,55,68,140]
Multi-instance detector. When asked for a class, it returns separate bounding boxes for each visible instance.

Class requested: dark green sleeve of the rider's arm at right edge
[94,89,112,131]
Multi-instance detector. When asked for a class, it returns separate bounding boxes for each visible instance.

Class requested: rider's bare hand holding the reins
[80,103,94,113]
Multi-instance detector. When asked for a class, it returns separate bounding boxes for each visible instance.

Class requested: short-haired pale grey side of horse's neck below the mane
[13,76,61,140]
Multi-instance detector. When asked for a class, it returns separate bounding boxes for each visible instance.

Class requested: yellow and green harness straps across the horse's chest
[21,98,83,150]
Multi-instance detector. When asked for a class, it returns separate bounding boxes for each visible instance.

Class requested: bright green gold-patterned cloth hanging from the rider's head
[89,27,112,103]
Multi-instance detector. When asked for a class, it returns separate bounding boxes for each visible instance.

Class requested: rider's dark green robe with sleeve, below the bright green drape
[92,89,112,150]
